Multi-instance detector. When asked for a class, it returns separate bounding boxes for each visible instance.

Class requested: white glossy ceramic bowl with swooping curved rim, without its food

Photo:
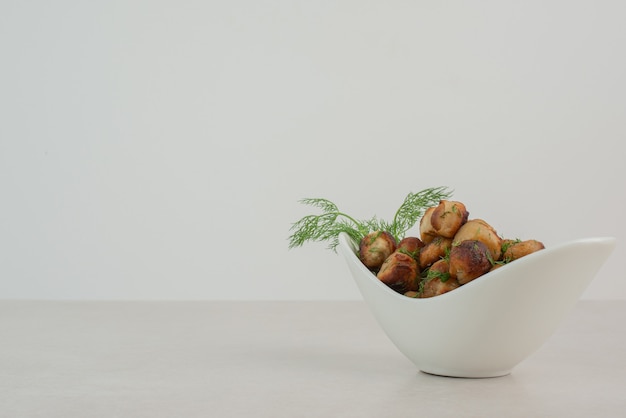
[337,234,616,378]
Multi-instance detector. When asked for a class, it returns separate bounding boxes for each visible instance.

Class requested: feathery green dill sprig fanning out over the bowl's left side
[289,187,451,251]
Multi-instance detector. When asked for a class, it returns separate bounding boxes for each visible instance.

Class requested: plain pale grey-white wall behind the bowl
[0,0,626,299]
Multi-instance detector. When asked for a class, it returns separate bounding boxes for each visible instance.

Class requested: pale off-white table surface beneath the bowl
[0,301,626,418]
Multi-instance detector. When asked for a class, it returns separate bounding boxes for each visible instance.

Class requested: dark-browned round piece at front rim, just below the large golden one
[450,240,491,285]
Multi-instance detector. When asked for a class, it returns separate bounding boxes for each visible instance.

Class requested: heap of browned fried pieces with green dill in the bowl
[290,187,545,298]
